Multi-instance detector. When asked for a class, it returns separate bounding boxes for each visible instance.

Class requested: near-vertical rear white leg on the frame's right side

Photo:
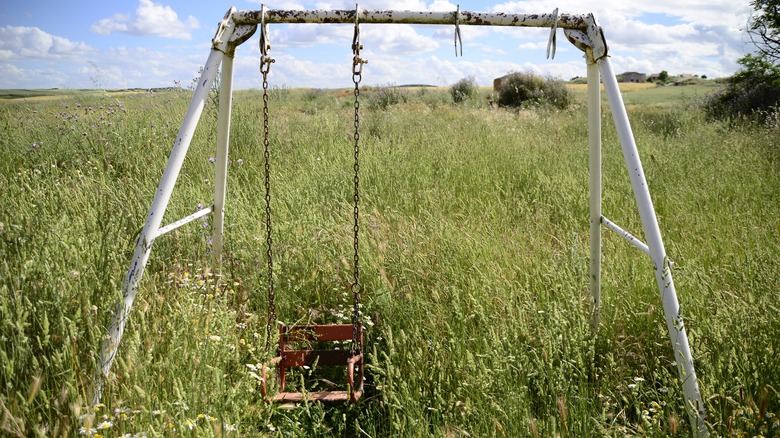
[588,59,601,336]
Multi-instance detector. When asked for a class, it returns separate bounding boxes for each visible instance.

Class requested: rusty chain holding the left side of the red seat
[260,57,276,354]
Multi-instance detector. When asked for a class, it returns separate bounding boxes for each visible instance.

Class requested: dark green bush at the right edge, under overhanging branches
[704,55,780,123]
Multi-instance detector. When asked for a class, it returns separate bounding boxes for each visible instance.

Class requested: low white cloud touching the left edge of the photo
[0,26,94,59]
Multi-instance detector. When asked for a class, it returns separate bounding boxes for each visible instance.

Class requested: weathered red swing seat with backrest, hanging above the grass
[260,324,363,403]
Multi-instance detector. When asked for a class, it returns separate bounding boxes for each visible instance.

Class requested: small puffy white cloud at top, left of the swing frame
[92,0,200,40]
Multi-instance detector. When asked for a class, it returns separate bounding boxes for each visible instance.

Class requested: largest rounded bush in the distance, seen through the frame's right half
[498,73,573,109]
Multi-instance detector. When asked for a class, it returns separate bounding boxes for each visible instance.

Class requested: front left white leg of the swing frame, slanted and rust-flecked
[93,50,224,404]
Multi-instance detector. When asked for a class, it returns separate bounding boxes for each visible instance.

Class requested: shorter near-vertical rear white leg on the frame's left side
[212,56,233,268]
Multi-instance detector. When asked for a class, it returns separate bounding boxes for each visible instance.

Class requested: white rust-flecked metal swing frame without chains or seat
[94,5,709,437]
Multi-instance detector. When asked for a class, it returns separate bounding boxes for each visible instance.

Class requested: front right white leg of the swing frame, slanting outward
[598,57,709,437]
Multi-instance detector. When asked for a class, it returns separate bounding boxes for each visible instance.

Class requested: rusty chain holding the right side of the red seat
[352,35,367,352]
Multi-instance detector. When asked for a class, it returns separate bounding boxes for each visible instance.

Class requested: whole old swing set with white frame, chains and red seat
[94,5,709,437]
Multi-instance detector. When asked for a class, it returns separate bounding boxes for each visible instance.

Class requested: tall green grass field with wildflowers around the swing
[0,87,780,437]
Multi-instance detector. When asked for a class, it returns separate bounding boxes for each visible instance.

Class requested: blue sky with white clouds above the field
[0,0,751,89]
